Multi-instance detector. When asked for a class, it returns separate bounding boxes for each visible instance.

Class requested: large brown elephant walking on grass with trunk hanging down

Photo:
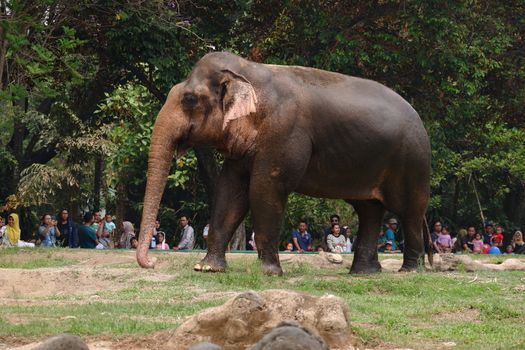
[137,52,431,275]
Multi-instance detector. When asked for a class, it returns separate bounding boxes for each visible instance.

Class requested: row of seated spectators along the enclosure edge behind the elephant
[0,209,525,254]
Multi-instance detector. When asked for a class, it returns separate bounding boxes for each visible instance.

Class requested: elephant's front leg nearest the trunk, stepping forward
[194,160,249,272]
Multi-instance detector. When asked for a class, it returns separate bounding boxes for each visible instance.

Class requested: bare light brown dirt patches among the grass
[0,250,525,350]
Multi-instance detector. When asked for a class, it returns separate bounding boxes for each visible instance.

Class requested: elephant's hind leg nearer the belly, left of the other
[350,200,385,273]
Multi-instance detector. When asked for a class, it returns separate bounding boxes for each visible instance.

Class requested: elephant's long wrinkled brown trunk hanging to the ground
[137,89,188,268]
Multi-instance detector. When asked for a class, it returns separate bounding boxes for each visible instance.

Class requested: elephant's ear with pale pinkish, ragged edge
[221,70,257,130]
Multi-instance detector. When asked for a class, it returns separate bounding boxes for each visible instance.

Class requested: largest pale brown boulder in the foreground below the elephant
[165,290,356,350]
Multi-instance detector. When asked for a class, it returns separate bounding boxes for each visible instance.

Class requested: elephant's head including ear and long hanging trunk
[137,53,258,268]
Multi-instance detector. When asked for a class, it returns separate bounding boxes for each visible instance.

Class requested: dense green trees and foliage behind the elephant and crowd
[0,0,525,232]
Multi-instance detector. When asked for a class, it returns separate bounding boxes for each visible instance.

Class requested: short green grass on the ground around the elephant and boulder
[0,251,525,349]
